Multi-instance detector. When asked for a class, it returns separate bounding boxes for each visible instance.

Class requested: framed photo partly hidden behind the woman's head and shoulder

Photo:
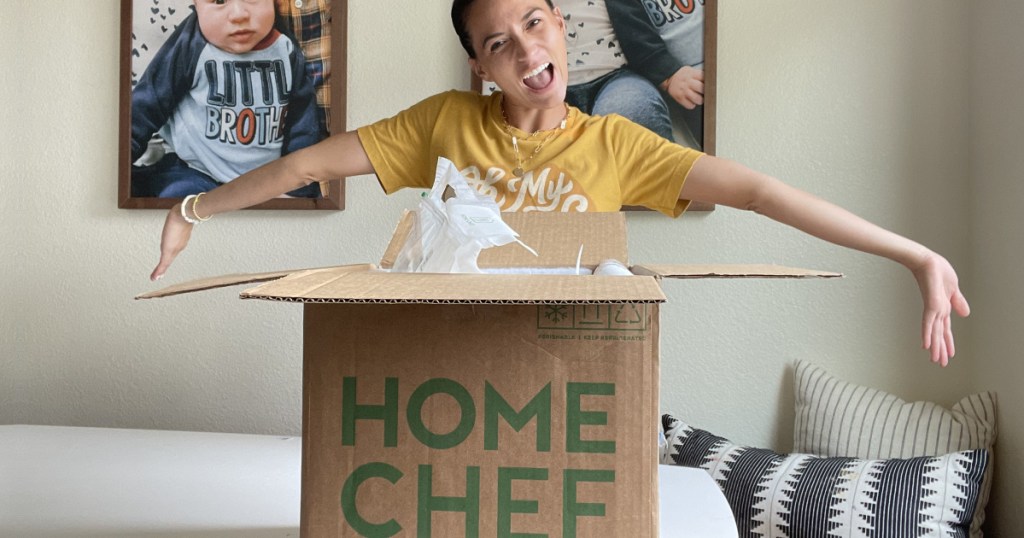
[471,0,718,211]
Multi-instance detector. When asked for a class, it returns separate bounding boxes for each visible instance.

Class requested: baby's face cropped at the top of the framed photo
[195,0,274,54]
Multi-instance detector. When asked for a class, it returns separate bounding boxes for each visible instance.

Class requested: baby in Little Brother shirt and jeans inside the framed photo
[131,0,324,198]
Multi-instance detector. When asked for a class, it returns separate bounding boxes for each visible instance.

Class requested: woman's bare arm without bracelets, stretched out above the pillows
[680,156,971,366]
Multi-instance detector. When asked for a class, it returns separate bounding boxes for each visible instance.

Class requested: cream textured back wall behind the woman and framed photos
[0,0,1007,528]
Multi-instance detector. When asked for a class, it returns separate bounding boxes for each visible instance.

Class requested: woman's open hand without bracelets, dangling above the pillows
[911,252,971,366]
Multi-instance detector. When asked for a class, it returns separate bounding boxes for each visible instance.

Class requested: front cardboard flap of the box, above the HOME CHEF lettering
[242,267,666,304]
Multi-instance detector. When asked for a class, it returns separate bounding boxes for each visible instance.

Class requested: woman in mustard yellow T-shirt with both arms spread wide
[151,0,970,366]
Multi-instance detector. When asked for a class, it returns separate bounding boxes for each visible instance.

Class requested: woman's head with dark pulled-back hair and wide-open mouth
[466,0,568,109]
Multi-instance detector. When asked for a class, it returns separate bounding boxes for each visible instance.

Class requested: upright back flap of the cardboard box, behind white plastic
[380,211,629,268]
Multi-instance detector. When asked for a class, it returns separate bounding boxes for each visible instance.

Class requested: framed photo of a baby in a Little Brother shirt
[118,0,347,210]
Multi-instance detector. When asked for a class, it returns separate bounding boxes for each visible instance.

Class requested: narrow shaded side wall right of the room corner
[967,0,1024,536]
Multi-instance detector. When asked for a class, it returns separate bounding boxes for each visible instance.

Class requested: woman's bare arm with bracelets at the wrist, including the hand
[150,131,374,280]
